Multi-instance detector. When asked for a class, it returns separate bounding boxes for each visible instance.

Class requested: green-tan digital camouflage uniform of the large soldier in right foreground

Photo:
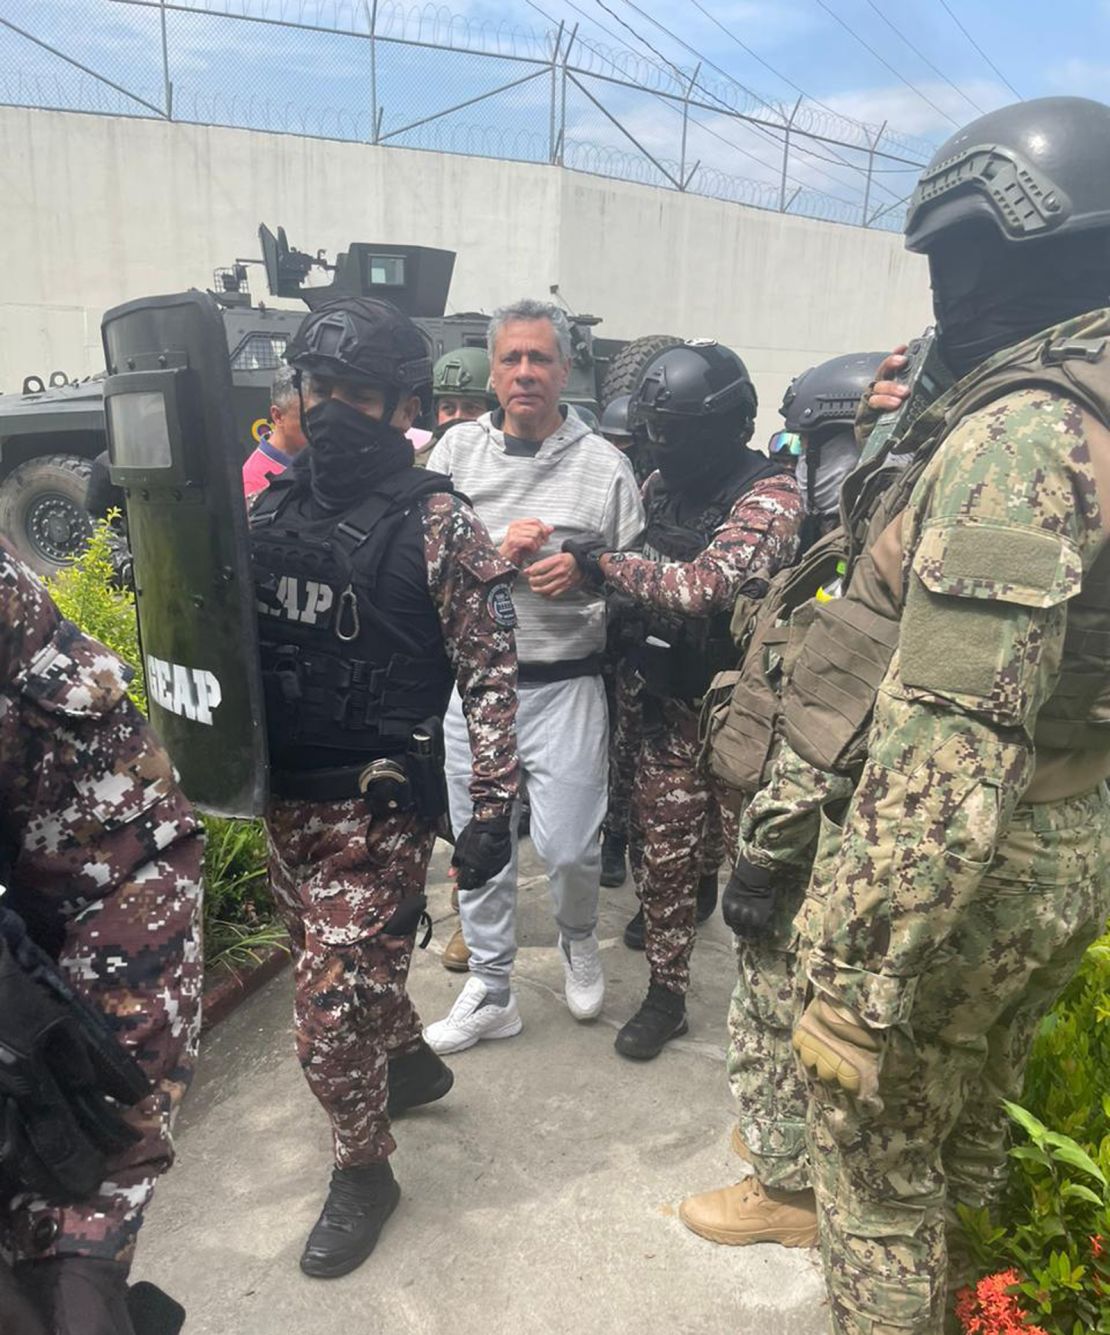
[801,360,1110,1335]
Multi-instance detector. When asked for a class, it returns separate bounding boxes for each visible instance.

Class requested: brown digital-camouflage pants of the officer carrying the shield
[266,800,435,1168]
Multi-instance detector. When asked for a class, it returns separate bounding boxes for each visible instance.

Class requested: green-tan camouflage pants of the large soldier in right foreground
[803,786,1110,1335]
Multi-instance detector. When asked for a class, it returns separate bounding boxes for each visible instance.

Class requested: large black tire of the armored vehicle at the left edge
[0,454,92,575]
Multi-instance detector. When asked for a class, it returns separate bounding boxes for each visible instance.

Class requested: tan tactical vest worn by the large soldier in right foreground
[783,311,1110,773]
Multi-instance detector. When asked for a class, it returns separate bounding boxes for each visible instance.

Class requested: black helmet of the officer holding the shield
[286,296,431,411]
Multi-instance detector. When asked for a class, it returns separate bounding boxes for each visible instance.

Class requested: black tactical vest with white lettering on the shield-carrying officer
[250,469,454,793]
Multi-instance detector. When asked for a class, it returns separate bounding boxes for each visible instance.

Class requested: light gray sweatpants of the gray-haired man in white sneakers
[443,677,609,988]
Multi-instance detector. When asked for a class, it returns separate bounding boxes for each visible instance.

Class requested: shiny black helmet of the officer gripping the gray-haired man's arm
[630,339,757,438]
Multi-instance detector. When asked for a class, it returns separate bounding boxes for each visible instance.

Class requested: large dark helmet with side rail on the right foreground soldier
[906,97,1110,251]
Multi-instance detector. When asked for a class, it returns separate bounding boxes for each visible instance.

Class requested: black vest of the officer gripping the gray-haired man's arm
[629,449,785,701]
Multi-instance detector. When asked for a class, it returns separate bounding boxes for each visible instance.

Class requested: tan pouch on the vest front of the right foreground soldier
[783,597,899,773]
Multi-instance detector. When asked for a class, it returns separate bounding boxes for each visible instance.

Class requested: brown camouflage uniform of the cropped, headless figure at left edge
[0,543,203,1263]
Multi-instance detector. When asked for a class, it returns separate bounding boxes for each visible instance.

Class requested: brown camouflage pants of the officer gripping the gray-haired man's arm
[633,700,737,993]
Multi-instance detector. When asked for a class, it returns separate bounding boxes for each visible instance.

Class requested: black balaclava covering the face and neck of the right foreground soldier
[928,226,1110,378]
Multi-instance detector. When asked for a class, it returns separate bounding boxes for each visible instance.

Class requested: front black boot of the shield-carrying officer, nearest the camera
[301,1159,401,1279]
